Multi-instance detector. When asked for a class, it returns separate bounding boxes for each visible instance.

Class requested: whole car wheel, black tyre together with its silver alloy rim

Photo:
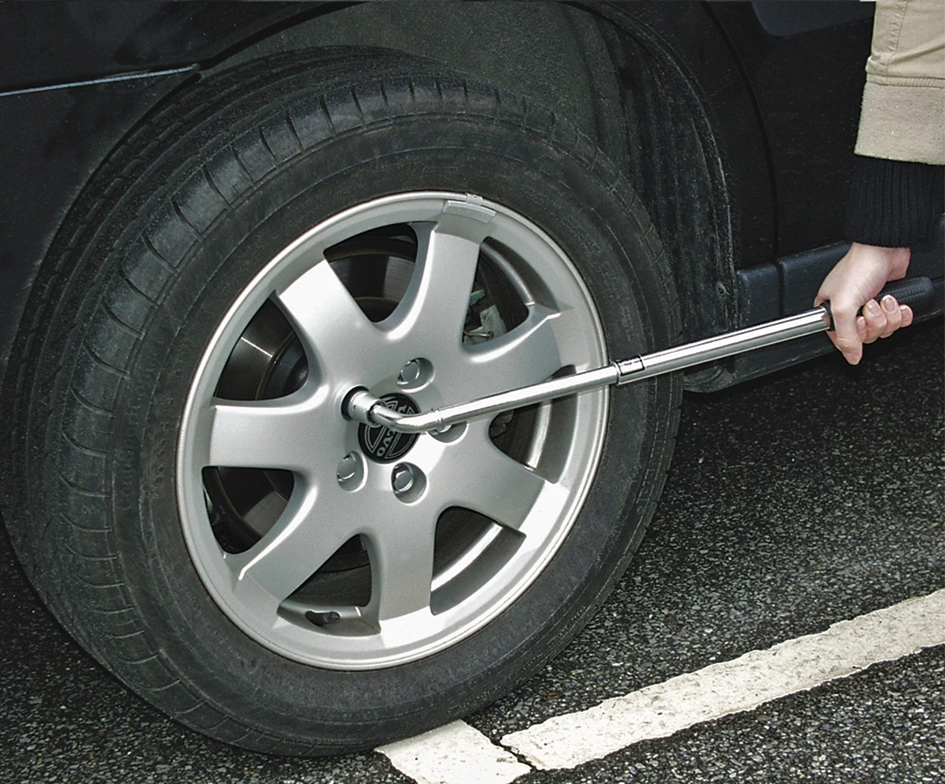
[4,52,681,754]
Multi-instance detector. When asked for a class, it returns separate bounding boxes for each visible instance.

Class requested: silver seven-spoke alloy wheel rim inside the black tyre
[177,192,608,670]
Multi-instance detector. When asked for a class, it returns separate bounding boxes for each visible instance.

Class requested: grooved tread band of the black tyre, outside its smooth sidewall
[4,46,681,754]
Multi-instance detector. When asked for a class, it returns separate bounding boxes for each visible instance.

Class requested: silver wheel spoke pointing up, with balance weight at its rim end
[381,220,485,350]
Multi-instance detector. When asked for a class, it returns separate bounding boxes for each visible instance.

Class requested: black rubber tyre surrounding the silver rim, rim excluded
[3,52,681,754]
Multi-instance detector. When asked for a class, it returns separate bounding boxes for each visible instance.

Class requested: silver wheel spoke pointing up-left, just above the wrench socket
[276,261,384,375]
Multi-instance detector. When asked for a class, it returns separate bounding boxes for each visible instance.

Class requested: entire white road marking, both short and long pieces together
[378,589,945,784]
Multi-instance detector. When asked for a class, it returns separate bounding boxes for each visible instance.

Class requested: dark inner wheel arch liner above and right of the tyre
[212,2,760,366]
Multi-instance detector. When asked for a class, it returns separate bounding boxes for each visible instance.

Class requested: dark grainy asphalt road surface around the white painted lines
[0,319,945,784]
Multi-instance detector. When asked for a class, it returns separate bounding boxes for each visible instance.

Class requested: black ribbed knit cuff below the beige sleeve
[846,156,945,248]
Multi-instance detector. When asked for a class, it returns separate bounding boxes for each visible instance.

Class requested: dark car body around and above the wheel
[0,2,941,402]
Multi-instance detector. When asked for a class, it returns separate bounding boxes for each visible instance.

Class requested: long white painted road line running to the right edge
[502,590,945,768]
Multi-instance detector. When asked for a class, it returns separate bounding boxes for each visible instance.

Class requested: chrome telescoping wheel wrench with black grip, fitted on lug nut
[342,278,934,433]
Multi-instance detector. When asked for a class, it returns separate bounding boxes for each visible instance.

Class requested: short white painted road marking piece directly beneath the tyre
[378,721,532,784]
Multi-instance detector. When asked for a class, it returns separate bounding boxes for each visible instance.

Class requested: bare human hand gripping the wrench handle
[814,242,912,365]
